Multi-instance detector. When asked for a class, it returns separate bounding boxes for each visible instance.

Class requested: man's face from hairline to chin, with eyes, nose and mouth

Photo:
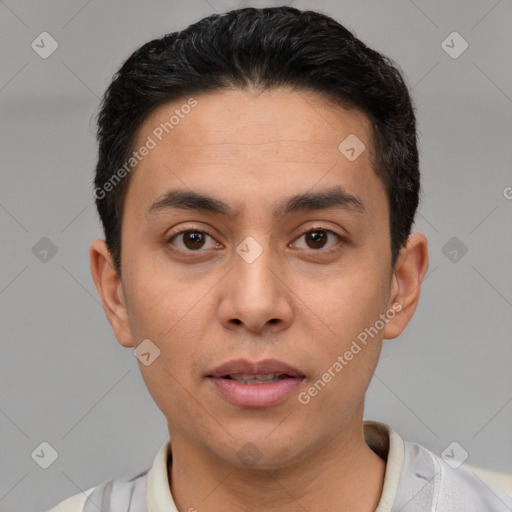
[94,89,422,467]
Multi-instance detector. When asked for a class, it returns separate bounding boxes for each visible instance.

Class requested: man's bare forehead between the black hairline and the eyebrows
[125,88,383,222]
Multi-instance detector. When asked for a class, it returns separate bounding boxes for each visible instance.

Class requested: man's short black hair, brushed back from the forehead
[94,6,420,276]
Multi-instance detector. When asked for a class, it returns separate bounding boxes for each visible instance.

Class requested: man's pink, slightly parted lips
[207,359,305,407]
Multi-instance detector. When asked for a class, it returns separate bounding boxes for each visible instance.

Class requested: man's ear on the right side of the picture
[383,233,428,339]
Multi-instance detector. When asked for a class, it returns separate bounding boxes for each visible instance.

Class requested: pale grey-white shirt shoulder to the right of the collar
[397,440,512,512]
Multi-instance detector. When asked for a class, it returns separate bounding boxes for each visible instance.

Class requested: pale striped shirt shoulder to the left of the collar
[48,469,149,512]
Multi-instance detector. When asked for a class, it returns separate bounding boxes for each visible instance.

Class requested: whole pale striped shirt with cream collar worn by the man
[48,420,512,512]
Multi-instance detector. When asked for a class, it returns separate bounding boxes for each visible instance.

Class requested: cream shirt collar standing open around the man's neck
[147,420,404,512]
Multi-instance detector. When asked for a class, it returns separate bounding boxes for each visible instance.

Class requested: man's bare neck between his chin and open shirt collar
[168,411,386,512]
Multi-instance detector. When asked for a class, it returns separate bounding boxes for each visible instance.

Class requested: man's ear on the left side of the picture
[89,239,134,347]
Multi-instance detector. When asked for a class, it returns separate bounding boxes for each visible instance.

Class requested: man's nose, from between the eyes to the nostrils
[218,237,293,334]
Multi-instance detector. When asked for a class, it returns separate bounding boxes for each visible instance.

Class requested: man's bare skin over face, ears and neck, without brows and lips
[90,88,428,512]
